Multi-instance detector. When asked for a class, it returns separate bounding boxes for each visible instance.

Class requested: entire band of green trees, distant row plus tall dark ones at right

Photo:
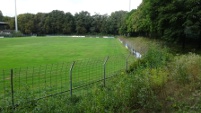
[0,0,201,48]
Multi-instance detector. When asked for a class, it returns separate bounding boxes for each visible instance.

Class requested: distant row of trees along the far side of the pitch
[0,10,127,35]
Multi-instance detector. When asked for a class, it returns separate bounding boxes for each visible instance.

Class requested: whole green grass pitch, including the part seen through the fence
[0,37,134,106]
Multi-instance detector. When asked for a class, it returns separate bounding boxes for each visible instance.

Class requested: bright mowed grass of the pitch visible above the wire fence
[0,37,128,69]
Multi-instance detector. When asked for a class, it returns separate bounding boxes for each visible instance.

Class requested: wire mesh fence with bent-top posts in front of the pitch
[0,55,135,110]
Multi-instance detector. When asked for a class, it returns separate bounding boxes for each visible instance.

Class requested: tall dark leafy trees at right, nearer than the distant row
[125,0,201,48]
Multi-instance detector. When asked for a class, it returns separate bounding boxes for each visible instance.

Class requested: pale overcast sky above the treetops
[0,0,142,16]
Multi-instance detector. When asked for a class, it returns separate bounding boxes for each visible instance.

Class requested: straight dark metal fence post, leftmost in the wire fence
[10,69,15,112]
